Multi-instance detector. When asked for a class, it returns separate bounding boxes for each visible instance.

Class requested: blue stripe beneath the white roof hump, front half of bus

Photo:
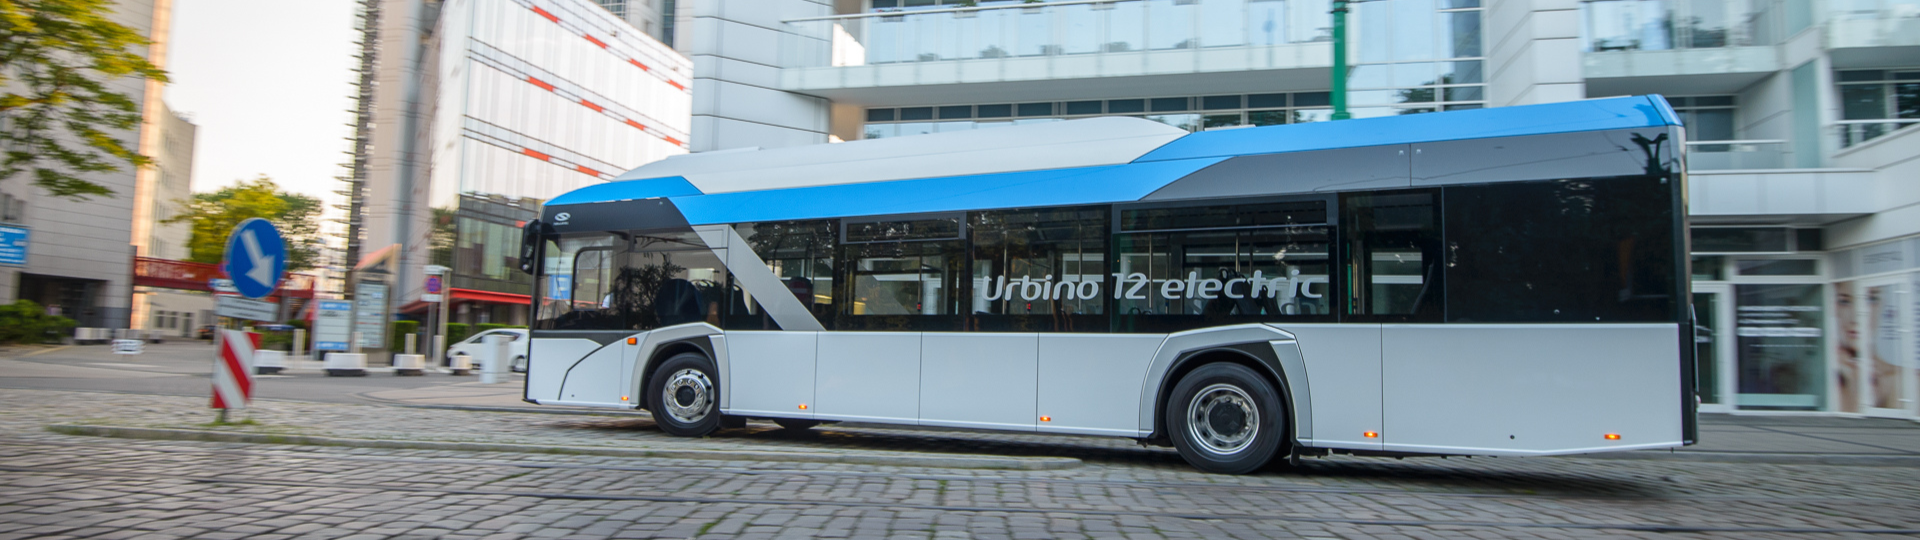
[672,158,1225,225]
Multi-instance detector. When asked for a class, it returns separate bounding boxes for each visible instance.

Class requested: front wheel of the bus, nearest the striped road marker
[647,352,720,436]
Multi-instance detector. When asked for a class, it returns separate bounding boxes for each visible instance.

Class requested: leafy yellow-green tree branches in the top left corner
[0,0,167,200]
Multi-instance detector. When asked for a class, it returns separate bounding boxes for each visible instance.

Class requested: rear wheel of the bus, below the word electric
[1162,363,1290,475]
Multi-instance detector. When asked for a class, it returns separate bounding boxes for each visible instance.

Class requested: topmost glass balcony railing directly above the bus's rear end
[1580,0,1784,52]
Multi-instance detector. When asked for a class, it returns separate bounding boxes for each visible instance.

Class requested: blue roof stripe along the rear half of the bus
[1135,96,1680,163]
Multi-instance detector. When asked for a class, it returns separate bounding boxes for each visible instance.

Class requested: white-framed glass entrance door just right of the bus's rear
[1734,284,1828,411]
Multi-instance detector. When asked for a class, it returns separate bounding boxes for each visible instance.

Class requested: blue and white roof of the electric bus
[547,96,1680,225]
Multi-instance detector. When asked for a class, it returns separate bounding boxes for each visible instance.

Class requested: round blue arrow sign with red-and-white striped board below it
[213,217,286,423]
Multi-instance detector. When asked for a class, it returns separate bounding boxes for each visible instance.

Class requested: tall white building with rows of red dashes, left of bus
[344,0,693,332]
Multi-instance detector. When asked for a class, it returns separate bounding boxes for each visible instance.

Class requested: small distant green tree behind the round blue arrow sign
[170,175,321,271]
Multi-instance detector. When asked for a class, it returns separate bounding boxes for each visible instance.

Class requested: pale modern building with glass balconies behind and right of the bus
[680,0,1920,417]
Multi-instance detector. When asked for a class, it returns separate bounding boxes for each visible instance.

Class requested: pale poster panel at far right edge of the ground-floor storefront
[1855,275,1916,417]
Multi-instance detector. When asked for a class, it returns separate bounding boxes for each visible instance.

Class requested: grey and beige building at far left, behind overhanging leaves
[0,0,184,329]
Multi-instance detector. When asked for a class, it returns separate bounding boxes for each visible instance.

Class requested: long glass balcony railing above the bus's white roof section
[781,0,1332,67]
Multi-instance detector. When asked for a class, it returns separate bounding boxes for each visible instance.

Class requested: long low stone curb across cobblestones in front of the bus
[46,425,1081,471]
